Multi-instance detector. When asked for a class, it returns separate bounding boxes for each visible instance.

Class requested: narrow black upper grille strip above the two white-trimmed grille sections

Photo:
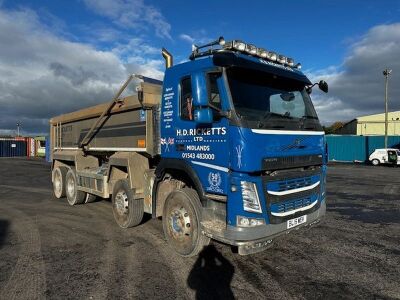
[262,154,323,171]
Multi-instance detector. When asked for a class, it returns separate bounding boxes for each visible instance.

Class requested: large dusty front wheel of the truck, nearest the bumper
[162,188,210,257]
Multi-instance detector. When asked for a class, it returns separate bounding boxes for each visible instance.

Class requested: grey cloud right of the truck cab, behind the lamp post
[310,23,400,123]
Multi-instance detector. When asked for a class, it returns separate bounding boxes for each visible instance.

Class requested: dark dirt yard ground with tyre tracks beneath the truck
[0,158,400,300]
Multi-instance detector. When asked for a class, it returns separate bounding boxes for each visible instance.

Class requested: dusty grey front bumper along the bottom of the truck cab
[203,200,326,255]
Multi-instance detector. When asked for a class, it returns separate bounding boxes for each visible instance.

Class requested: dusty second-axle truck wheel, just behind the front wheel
[112,179,144,228]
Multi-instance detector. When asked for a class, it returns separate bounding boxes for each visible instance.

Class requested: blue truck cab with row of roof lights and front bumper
[156,41,327,254]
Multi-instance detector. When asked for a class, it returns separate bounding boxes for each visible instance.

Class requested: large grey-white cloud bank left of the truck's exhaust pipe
[0,9,161,134]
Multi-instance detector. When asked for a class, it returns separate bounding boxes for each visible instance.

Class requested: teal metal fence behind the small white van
[326,135,400,162]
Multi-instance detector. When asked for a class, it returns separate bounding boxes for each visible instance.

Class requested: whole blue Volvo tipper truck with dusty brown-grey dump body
[50,37,328,256]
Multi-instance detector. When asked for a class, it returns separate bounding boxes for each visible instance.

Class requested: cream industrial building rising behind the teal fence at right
[335,111,400,136]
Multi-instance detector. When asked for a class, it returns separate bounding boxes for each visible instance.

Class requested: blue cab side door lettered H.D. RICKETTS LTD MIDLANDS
[175,71,229,194]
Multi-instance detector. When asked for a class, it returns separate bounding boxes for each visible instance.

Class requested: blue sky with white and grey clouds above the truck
[0,0,400,134]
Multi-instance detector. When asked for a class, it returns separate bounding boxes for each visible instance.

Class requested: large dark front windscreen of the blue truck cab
[227,67,322,131]
